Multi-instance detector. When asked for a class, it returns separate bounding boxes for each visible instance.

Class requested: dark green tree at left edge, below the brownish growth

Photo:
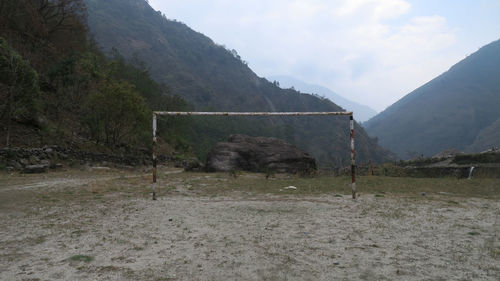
[0,37,39,146]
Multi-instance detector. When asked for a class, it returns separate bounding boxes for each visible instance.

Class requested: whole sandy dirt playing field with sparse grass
[0,169,500,280]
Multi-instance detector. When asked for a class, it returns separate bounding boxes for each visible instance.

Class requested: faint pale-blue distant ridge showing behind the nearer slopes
[267,75,377,122]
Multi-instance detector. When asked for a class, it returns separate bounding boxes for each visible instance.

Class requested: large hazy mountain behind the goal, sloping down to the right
[85,0,389,165]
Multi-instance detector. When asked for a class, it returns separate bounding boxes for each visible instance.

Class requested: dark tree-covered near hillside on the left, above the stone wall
[0,0,187,151]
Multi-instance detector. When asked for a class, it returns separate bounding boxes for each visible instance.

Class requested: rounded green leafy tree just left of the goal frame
[85,80,151,147]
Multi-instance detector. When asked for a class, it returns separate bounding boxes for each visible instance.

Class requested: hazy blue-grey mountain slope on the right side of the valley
[364,40,500,158]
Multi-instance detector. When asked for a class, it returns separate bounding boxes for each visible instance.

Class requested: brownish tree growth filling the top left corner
[0,0,87,72]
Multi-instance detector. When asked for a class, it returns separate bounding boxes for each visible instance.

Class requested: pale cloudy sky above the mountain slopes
[149,0,500,111]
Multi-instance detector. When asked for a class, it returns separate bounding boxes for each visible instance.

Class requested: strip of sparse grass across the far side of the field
[0,167,500,210]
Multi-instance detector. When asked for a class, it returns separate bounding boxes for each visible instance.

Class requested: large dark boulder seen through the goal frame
[206,135,316,174]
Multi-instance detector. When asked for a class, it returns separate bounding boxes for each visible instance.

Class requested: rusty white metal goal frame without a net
[152,111,356,200]
